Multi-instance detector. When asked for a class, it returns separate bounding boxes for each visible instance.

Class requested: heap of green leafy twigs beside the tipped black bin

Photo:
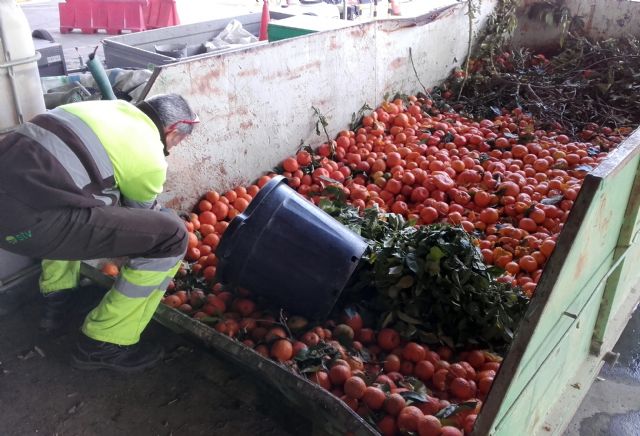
[320,201,528,349]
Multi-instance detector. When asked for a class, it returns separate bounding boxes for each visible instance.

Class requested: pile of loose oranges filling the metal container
[164,90,624,436]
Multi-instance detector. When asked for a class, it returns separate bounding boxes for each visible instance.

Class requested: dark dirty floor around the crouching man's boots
[0,289,311,436]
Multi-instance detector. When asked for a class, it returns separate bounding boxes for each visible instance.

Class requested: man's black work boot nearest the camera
[71,335,164,372]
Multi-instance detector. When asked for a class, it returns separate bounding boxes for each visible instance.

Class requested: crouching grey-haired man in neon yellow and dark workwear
[0,94,198,372]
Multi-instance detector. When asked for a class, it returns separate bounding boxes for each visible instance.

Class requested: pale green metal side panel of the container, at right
[475,132,640,435]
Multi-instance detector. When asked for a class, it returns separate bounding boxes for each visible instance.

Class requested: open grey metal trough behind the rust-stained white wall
[103,12,291,68]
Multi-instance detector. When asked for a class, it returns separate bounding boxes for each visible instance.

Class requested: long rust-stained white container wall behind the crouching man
[142,0,496,209]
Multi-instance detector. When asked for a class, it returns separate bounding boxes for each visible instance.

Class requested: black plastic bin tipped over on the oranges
[216,176,367,318]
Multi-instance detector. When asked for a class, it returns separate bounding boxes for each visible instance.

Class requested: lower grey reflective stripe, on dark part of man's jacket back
[16,123,91,189]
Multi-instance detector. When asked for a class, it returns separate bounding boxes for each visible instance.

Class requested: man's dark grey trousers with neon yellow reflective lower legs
[0,204,188,345]
